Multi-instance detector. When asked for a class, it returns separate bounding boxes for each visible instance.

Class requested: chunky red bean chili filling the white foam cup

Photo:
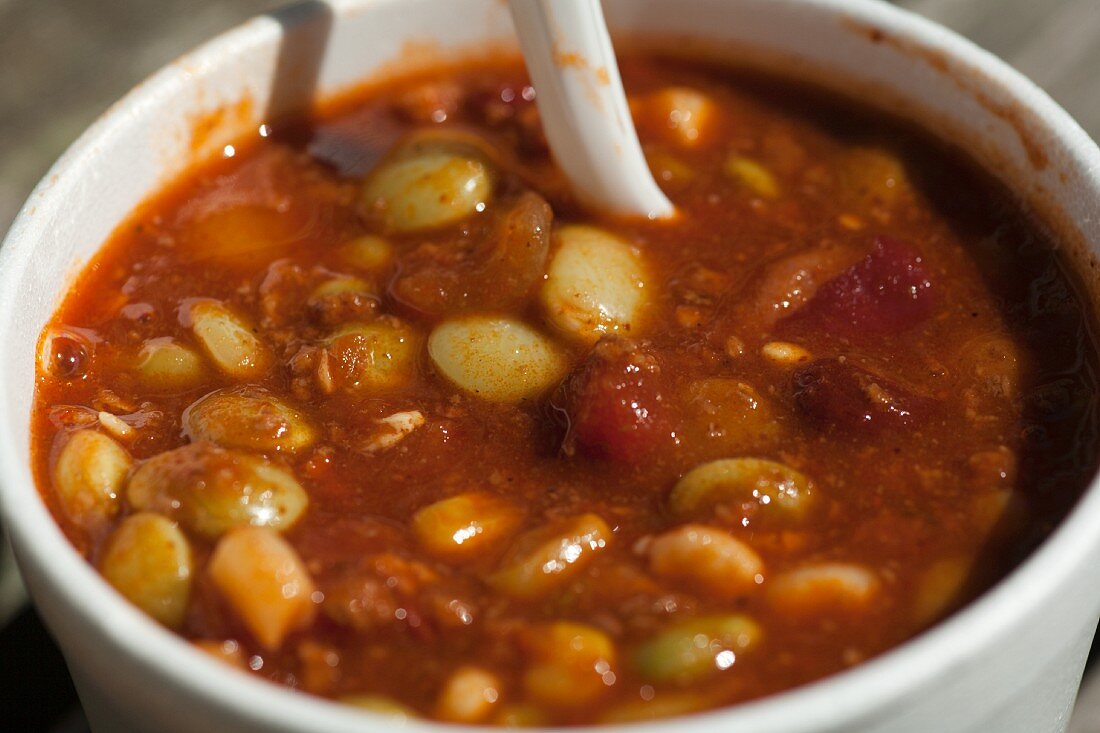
[33,53,1098,725]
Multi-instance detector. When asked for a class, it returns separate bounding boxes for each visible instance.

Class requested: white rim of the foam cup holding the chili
[0,0,1100,733]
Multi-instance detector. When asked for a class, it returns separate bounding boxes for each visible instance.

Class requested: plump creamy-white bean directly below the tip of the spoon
[540,225,648,343]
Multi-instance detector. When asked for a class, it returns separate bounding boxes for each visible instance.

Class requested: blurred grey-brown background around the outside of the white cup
[0,0,1100,733]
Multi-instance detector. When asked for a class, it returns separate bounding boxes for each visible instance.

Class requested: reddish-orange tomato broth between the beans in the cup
[33,55,1097,724]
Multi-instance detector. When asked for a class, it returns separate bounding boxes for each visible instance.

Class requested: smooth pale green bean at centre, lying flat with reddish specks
[428,316,568,402]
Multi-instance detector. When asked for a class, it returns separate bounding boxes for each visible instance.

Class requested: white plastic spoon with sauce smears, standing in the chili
[510,0,675,219]
